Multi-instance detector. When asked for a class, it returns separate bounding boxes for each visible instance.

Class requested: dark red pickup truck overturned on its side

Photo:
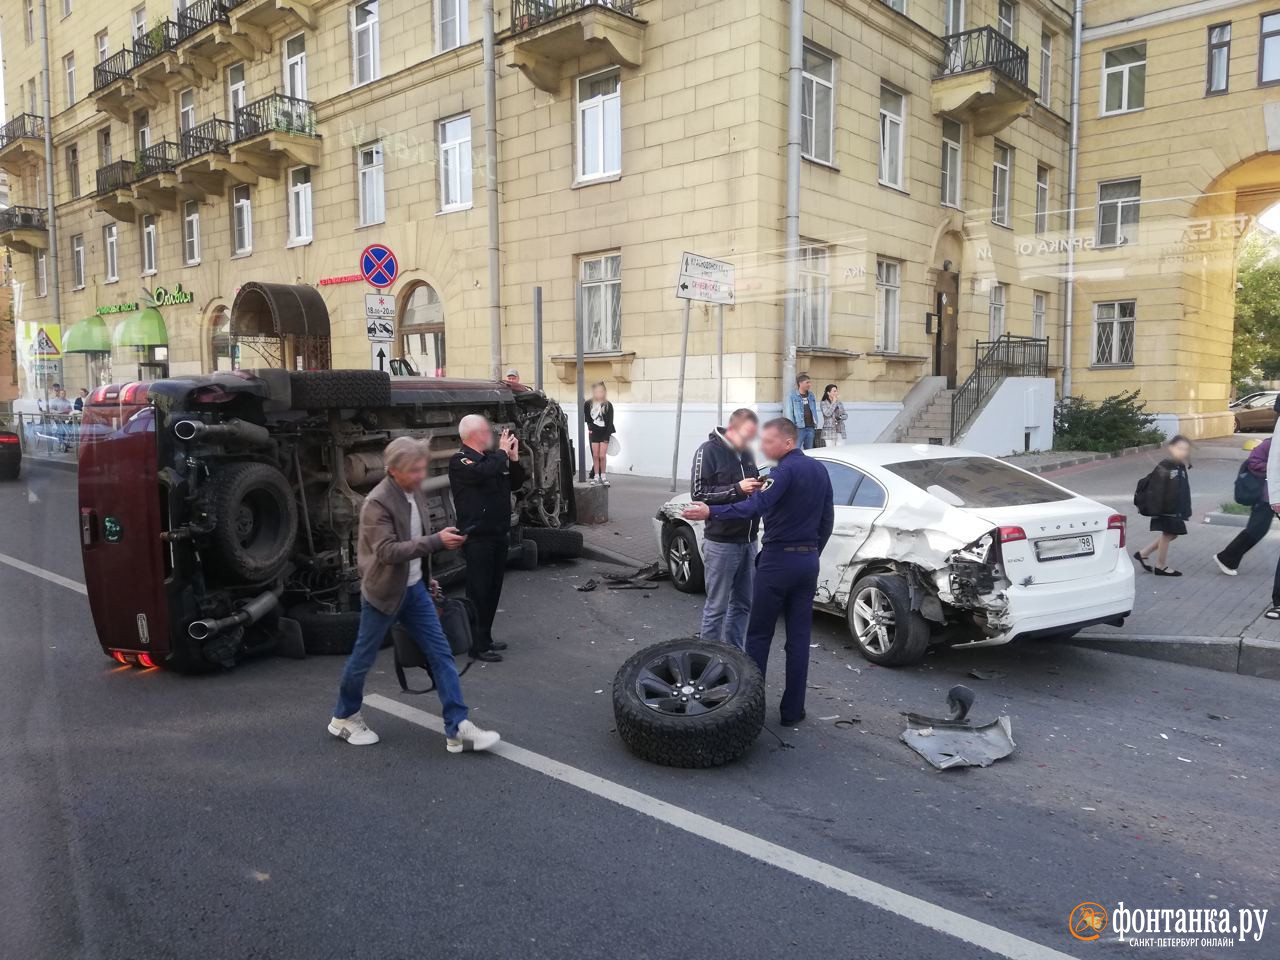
[79,370,581,672]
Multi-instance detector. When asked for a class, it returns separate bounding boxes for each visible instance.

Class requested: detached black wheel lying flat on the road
[613,640,764,768]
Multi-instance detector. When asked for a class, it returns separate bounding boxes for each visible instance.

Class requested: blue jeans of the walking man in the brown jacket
[333,581,467,737]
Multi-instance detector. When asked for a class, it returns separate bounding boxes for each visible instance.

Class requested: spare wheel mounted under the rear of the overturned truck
[204,462,298,582]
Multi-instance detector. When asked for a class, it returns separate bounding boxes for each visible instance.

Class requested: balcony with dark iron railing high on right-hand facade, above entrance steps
[932,27,1036,137]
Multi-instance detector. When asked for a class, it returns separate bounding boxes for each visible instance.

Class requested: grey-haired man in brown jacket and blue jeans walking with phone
[329,436,500,754]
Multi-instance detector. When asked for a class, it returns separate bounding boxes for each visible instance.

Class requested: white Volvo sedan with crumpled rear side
[653,443,1134,666]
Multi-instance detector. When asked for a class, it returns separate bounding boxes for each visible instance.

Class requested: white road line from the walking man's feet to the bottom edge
[365,694,1075,960]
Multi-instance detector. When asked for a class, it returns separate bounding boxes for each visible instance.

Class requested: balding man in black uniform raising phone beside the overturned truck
[449,413,525,663]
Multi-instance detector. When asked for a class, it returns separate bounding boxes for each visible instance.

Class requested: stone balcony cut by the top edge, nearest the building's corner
[507,0,646,93]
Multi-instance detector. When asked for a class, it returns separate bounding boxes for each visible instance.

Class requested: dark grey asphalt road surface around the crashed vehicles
[0,466,1280,960]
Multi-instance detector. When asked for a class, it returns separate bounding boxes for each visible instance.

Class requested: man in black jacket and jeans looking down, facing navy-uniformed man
[689,407,760,649]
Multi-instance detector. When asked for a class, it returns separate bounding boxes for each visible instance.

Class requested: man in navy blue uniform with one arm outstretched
[685,417,836,726]
